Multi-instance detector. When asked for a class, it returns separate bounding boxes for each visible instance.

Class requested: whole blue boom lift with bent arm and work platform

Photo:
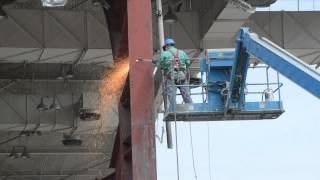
[165,28,320,121]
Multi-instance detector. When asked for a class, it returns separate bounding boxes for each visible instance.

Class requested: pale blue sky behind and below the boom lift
[156,0,320,180]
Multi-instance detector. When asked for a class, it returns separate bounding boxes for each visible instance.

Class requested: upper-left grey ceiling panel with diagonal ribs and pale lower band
[0,7,113,64]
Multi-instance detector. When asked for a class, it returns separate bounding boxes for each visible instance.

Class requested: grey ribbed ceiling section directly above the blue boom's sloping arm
[246,11,320,65]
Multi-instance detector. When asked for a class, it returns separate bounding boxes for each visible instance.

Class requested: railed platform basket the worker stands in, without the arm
[163,61,284,121]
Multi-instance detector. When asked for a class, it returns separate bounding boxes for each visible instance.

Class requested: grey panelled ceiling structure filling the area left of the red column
[0,0,120,180]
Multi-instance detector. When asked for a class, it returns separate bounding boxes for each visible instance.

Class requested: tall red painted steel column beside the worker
[127,0,156,180]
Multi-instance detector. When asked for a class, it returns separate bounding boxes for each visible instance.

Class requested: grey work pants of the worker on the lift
[166,79,193,112]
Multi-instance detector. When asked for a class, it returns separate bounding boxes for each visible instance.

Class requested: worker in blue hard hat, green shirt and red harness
[160,38,192,112]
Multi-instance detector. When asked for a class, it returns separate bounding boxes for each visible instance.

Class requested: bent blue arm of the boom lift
[226,28,320,111]
